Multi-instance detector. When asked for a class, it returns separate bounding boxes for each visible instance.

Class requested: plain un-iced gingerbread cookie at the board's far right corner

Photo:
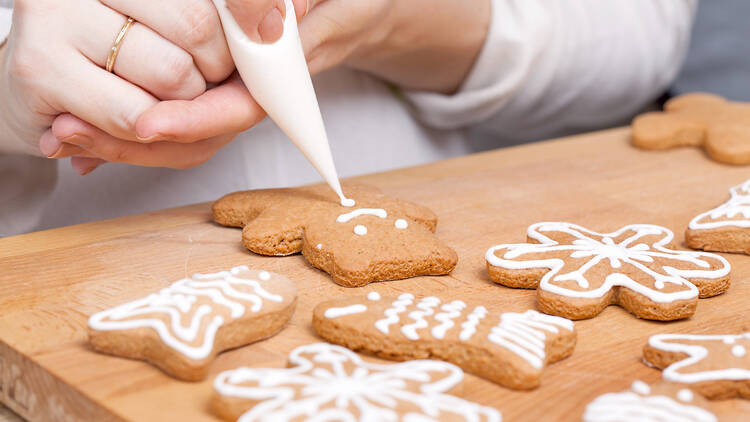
[632,93,750,164]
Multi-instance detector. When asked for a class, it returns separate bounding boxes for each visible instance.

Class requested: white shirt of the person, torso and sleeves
[0,0,696,236]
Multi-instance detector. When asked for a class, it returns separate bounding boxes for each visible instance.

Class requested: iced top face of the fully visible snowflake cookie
[485,223,730,303]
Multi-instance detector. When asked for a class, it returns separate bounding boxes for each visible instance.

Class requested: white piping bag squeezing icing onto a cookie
[213,0,354,206]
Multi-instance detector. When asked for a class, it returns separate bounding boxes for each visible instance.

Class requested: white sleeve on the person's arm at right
[406,0,697,142]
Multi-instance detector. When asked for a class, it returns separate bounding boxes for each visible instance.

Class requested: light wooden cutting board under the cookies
[0,129,750,421]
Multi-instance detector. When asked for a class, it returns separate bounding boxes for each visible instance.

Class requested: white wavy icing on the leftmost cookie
[89,266,284,360]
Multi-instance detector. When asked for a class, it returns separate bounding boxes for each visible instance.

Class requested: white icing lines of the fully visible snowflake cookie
[485,223,730,303]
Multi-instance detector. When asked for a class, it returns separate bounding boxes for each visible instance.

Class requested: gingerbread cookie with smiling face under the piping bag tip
[213,185,458,287]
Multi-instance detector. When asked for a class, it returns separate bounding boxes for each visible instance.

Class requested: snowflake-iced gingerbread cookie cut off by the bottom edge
[212,343,501,422]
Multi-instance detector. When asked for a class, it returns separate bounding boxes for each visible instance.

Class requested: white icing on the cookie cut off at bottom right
[583,391,717,422]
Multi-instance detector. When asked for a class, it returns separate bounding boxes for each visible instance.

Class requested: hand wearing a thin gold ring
[0,0,238,170]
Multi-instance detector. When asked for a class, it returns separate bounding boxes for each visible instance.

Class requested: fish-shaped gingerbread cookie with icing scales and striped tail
[313,292,576,389]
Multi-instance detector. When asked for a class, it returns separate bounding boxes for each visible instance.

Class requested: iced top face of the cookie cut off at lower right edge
[646,332,750,386]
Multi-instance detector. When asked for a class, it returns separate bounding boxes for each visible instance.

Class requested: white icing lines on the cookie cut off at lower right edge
[648,332,750,384]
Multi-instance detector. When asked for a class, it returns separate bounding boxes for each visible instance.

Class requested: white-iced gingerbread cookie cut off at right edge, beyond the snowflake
[685,180,750,254]
